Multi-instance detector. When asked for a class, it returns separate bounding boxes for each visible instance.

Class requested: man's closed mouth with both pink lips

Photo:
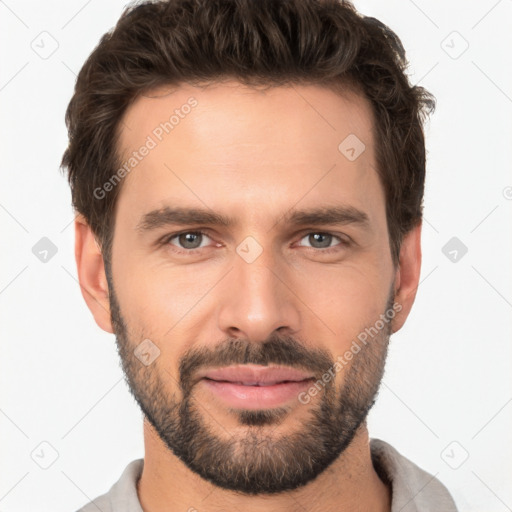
[199,365,314,409]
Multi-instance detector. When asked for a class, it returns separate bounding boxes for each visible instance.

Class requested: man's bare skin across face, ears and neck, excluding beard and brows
[75,81,421,512]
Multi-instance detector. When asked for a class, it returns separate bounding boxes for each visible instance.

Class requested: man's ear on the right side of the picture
[392,221,421,332]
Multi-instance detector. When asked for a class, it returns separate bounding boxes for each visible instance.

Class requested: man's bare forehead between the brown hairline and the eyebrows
[114,81,383,229]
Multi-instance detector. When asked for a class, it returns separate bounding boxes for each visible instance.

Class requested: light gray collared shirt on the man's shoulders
[77,439,457,512]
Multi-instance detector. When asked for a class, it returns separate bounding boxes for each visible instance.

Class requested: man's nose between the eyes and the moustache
[218,245,301,342]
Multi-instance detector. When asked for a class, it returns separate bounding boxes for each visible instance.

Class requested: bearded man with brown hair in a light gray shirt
[62,0,456,512]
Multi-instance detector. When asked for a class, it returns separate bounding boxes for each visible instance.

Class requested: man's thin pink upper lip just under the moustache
[199,364,314,386]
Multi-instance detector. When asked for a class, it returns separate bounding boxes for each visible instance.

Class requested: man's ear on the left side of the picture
[75,214,114,333]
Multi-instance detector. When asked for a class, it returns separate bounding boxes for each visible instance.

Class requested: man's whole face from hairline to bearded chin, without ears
[107,82,395,493]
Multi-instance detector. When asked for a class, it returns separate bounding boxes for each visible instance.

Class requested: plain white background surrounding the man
[0,0,512,512]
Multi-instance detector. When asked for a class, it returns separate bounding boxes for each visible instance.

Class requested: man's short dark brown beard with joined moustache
[106,270,394,495]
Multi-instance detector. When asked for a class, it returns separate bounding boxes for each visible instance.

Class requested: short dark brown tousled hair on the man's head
[61,0,435,265]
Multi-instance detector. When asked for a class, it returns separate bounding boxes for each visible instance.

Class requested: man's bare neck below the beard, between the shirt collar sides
[137,419,391,512]
